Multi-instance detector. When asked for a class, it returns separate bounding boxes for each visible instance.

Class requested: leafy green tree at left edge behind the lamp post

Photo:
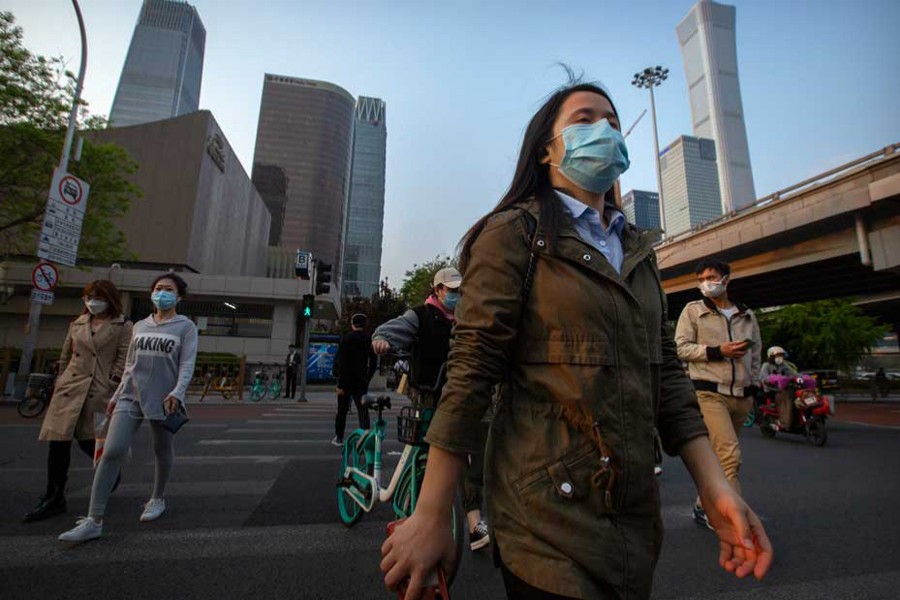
[0,12,141,262]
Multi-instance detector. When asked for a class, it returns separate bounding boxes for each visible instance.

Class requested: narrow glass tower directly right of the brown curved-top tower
[341,96,387,297]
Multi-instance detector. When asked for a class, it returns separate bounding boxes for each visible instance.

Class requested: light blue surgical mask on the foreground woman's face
[550,119,631,194]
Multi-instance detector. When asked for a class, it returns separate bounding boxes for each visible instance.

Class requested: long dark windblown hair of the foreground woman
[459,71,618,272]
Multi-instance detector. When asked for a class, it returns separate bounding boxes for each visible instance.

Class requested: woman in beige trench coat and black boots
[24,280,132,523]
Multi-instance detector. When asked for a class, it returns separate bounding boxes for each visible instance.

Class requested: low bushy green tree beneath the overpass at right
[759,299,890,371]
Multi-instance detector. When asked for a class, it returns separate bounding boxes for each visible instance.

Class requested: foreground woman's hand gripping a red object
[381,506,456,600]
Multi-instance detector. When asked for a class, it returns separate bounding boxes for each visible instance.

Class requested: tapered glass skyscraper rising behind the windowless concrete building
[109,0,206,127]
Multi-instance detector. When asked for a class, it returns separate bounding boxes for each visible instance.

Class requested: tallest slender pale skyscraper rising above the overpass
[680,0,756,213]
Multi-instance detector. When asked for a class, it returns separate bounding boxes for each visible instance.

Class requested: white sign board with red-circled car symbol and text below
[38,169,90,267]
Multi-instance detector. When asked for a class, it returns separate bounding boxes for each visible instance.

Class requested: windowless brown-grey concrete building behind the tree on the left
[88,111,271,277]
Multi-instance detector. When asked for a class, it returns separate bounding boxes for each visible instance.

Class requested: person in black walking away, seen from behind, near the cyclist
[331,313,377,446]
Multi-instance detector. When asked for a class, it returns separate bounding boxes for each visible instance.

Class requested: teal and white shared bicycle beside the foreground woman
[337,368,465,581]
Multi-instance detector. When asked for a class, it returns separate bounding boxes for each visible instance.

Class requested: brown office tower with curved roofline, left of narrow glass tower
[252,73,356,278]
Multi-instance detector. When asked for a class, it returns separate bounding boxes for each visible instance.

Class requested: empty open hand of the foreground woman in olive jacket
[700,482,773,579]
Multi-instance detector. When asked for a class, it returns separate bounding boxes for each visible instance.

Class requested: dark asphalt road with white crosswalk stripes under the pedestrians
[0,394,900,600]
